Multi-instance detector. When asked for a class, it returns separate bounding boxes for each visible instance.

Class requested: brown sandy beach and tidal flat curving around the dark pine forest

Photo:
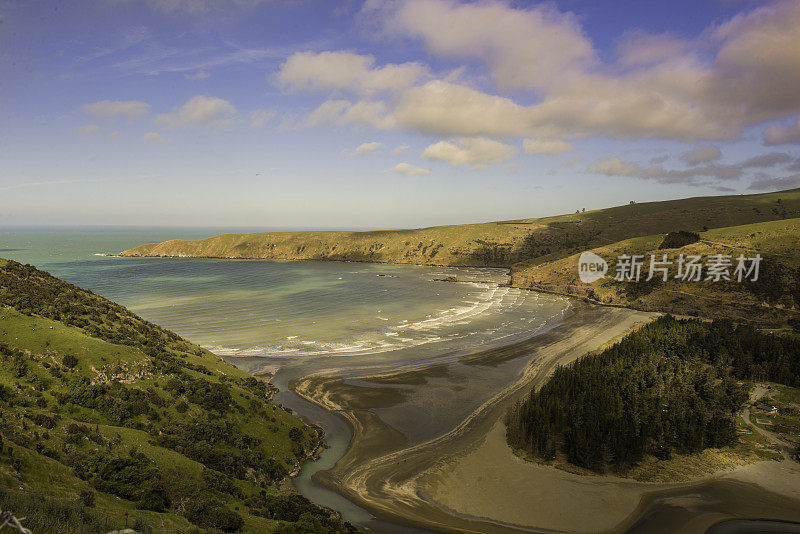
[290,304,800,534]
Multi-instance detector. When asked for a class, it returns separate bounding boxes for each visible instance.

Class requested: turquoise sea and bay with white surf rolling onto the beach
[0,228,564,370]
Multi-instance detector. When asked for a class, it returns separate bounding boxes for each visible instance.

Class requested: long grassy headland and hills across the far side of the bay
[121,189,800,323]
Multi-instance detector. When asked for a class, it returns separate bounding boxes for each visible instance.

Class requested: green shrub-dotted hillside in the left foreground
[0,260,351,533]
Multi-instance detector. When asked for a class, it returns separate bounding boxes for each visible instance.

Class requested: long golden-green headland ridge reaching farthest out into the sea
[122,189,800,267]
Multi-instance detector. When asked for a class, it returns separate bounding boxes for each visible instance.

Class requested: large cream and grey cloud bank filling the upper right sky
[277,0,800,143]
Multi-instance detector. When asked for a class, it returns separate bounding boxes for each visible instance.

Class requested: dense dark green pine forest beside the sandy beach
[507,316,800,472]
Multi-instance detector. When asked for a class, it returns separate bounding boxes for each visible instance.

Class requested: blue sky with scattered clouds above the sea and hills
[0,0,800,229]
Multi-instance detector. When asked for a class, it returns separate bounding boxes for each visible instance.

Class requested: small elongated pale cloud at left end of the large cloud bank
[276,51,427,94]
